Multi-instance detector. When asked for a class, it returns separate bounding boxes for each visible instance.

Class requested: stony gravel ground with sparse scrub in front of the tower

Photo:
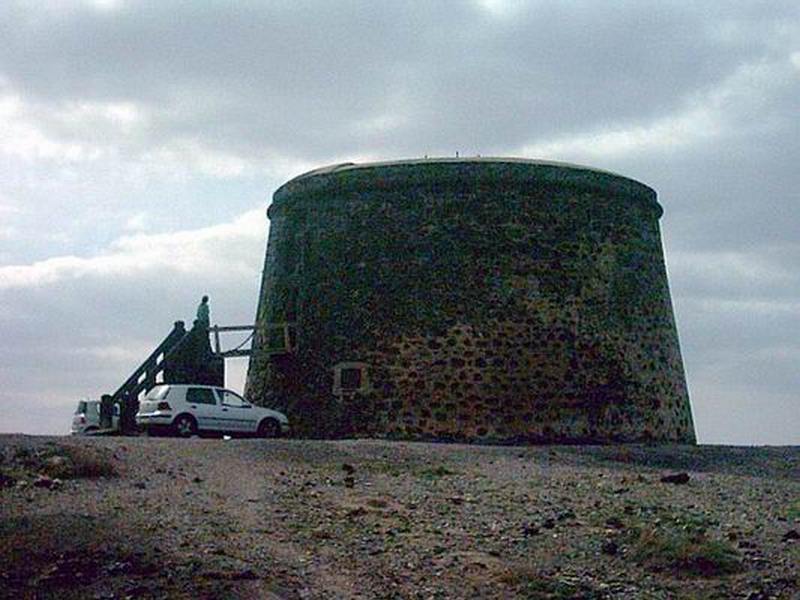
[0,436,800,600]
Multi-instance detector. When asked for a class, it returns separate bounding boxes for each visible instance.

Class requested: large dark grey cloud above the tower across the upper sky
[0,2,797,160]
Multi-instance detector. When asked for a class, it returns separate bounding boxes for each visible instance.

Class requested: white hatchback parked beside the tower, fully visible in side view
[136,384,289,437]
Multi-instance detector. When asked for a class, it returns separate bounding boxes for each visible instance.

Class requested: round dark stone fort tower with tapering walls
[246,158,695,443]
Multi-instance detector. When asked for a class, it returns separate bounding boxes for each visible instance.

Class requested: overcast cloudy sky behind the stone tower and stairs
[0,0,800,444]
